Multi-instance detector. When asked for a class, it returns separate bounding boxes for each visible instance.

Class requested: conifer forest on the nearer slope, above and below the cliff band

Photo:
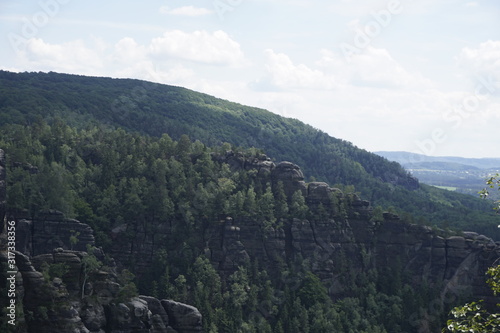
[0,121,460,333]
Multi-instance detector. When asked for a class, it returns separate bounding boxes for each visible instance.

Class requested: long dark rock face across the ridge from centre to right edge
[208,154,500,303]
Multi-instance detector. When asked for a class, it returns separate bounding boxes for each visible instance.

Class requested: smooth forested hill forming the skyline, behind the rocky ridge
[0,71,500,239]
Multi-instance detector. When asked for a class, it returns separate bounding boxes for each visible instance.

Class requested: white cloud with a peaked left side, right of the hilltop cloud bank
[254,49,335,90]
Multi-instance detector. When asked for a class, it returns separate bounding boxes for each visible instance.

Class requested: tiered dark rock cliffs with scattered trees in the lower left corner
[0,150,202,333]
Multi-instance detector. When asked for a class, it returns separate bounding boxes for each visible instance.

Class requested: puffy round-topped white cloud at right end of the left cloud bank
[149,30,246,66]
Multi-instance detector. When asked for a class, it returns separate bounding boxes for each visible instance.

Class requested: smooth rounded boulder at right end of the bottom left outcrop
[161,300,203,333]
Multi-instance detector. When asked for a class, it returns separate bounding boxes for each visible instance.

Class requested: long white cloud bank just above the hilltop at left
[11,30,248,86]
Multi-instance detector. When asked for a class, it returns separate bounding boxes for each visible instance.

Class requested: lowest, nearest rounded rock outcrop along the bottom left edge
[0,249,202,333]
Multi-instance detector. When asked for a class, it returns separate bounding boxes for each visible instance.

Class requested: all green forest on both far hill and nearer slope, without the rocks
[0,72,498,333]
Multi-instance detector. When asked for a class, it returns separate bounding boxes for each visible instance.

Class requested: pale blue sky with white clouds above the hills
[0,0,500,157]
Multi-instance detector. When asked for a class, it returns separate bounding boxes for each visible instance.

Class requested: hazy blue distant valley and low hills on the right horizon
[375,151,500,199]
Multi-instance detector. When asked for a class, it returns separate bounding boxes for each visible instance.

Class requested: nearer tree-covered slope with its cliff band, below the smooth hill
[0,121,498,333]
